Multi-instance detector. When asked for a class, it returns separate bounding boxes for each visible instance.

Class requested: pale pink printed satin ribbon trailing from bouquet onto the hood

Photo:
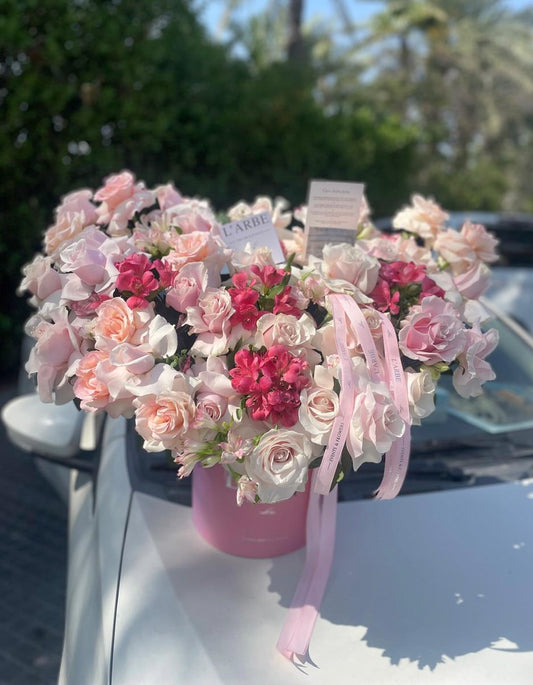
[277,294,411,659]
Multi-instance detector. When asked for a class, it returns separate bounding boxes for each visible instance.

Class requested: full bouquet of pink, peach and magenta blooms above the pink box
[21,171,497,656]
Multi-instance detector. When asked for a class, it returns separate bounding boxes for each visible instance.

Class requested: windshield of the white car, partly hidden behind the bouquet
[128,308,533,504]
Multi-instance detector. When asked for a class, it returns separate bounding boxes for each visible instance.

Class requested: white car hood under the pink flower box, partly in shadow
[112,481,533,685]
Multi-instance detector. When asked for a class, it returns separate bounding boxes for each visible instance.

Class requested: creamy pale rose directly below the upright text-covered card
[322,243,380,293]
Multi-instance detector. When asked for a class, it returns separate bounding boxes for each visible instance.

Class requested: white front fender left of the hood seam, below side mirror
[59,418,132,685]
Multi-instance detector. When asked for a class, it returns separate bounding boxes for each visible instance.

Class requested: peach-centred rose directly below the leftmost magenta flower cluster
[94,297,153,350]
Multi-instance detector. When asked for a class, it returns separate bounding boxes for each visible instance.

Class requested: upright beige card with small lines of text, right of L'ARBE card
[305,181,364,257]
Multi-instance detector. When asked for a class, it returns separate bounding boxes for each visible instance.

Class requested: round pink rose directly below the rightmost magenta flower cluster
[398,295,467,365]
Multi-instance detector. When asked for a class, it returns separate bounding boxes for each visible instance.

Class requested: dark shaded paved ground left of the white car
[0,384,67,685]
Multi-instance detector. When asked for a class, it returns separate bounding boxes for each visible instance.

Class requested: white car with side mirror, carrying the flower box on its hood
[3,306,533,685]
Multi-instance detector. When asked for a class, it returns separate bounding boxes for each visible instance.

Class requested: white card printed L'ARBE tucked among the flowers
[220,212,285,264]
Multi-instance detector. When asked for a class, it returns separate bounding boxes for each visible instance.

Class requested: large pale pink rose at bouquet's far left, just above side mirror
[26,307,81,403]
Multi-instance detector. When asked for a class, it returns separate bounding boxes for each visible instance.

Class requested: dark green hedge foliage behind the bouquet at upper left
[0,0,413,370]
